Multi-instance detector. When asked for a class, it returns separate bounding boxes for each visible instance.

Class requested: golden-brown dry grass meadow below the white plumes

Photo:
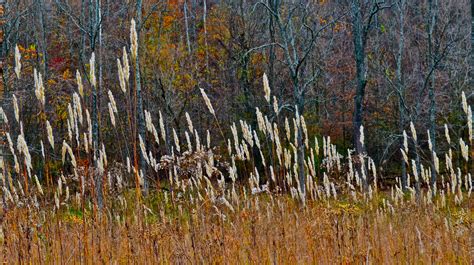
[0,188,474,264]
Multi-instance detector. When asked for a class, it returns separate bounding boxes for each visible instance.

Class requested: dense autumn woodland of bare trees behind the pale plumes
[1,0,474,185]
